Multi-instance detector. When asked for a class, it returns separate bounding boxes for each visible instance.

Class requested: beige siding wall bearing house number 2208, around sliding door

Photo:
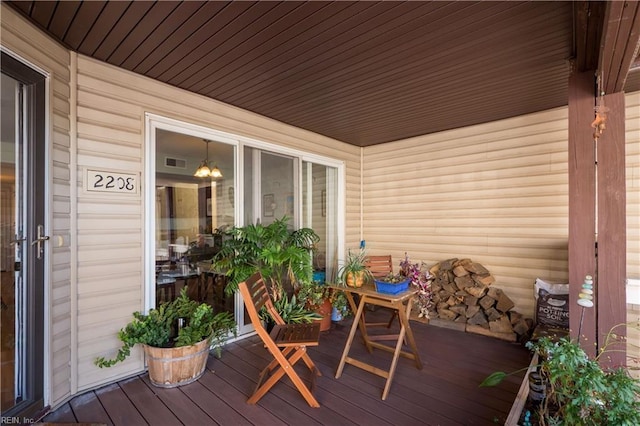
[76,56,360,389]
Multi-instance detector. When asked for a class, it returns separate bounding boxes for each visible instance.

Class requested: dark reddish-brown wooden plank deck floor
[43,311,530,426]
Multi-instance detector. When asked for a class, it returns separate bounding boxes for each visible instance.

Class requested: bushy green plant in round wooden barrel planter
[95,287,237,387]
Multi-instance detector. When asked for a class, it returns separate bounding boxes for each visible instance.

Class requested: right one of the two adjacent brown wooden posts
[596,91,627,367]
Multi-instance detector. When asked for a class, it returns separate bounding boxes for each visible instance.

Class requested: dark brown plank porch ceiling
[6,1,640,146]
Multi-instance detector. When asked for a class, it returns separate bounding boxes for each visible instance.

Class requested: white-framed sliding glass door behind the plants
[146,117,343,335]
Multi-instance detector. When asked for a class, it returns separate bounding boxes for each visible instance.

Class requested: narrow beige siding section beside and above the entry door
[0,4,73,405]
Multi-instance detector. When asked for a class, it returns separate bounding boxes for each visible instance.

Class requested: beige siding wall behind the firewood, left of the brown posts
[364,108,568,316]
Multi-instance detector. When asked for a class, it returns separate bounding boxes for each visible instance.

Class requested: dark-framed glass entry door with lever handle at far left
[0,57,46,419]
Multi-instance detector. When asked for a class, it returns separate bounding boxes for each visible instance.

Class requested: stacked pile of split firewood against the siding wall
[429,258,533,342]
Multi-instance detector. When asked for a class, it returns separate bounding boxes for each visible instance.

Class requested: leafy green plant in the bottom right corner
[480,325,640,426]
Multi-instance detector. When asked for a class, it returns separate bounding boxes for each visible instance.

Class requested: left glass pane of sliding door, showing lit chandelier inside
[155,129,235,324]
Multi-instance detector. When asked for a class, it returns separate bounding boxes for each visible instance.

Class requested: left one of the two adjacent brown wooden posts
[568,70,598,357]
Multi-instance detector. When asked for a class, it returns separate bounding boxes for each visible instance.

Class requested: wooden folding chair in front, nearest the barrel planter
[239,273,321,407]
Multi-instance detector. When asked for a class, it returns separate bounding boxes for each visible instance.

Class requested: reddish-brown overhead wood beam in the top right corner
[598,1,640,93]
